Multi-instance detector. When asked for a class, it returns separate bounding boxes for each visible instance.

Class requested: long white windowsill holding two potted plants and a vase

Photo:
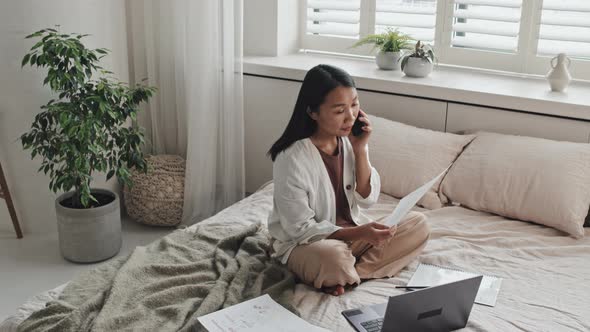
[244,53,590,120]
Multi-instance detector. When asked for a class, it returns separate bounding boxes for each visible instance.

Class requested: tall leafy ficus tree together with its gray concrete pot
[20,29,155,262]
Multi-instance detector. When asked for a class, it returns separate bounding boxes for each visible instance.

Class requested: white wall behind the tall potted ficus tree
[0,0,129,233]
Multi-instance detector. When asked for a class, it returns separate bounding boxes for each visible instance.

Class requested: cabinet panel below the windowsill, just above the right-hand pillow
[447,103,590,143]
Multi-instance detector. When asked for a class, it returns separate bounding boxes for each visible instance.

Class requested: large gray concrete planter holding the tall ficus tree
[55,189,121,263]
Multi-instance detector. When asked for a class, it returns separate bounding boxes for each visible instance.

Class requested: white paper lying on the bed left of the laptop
[198,294,329,332]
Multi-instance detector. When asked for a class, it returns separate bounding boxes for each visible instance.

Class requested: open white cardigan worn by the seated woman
[268,137,381,264]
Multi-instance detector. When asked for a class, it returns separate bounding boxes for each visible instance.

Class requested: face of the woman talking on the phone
[310,86,360,136]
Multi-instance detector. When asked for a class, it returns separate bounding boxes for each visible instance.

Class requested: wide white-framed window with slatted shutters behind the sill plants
[300,0,590,80]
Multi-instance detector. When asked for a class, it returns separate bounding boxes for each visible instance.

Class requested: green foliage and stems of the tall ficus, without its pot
[20,29,155,208]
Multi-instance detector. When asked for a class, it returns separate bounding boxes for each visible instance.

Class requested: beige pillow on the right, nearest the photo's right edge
[440,132,590,238]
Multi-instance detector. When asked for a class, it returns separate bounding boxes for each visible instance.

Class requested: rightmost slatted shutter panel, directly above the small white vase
[537,0,590,59]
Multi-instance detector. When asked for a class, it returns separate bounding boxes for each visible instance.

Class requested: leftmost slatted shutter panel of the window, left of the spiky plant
[306,0,361,38]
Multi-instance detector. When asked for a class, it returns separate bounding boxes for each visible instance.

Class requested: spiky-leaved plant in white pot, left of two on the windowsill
[352,28,412,70]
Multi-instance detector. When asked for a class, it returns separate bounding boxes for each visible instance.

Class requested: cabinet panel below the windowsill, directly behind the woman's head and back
[244,75,446,192]
